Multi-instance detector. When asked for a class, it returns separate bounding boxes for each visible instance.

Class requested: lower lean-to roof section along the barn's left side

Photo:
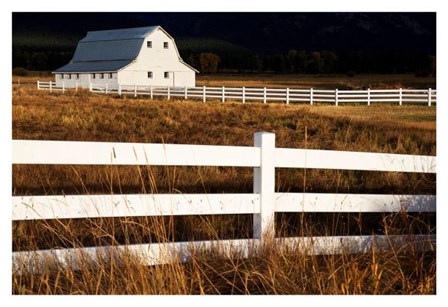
[54,60,132,73]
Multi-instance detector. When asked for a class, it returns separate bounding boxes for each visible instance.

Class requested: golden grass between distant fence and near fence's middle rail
[12,85,436,194]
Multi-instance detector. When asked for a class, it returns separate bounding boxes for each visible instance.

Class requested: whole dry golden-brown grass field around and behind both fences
[12,77,436,294]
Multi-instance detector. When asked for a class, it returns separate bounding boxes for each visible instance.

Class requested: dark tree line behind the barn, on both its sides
[13,47,436,76]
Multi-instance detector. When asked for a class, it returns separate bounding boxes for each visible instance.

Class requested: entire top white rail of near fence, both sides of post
[12,140,436,173]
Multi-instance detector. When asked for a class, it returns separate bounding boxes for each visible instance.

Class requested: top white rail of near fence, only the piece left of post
[12,140,260,167]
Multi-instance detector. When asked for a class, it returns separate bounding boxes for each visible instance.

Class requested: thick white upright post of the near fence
[253,132,275,241]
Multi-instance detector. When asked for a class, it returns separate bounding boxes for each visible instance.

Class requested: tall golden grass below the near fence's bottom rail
[13,241,436,295]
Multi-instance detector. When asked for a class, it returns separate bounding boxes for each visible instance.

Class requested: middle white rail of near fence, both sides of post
[12,193,436,221]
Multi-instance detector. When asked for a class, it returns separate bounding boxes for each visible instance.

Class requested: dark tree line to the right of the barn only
[186,50,436,76]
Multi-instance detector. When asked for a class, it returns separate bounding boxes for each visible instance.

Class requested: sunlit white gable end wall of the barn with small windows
[118,29,196,87]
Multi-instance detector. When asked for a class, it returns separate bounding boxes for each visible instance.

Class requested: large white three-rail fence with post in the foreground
[12,132,436,270]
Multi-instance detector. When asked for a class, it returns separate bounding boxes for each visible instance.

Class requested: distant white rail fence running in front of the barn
[37,81,437,106]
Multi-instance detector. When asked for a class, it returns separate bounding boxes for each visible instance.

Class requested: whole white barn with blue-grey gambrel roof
[53,26,198,88]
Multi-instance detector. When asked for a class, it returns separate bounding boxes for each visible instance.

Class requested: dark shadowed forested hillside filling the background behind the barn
[12,13,436,76]
